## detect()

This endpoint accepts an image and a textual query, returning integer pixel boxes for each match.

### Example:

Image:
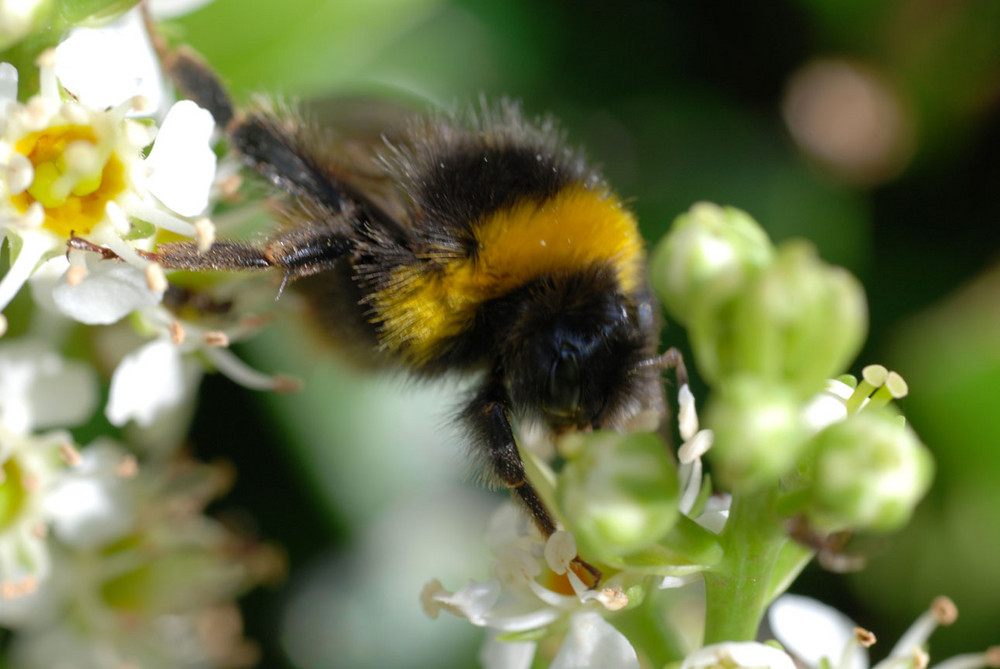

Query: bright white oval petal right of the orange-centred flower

[146,100,216,216]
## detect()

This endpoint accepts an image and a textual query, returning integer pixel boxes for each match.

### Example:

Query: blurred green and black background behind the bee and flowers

[169,0,1000,669]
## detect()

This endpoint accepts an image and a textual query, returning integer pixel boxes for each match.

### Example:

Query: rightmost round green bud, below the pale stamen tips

[805,409,934,532]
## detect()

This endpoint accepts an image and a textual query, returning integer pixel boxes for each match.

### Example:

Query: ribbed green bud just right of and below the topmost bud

[689,241,868,396]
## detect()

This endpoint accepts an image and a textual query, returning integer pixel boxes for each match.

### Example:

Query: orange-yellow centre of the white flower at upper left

[11,125,125,237]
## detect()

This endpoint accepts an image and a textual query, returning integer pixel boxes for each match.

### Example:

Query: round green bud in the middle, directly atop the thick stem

[705,376,808,491]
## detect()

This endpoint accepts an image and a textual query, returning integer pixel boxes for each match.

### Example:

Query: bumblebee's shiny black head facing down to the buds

[505,272,658,432]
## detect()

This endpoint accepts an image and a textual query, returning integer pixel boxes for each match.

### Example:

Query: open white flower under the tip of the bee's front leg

[421,503,639,669]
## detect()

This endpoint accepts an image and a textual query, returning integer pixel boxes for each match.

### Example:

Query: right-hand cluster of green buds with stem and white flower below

[425,204,960,669]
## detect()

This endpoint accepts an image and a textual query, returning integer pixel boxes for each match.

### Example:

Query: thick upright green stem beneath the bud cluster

[704,491,788,645]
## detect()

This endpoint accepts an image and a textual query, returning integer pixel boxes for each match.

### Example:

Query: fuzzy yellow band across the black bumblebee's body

[372,187,644,364]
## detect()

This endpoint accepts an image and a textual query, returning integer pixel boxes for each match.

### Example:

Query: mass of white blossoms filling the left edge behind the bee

[0,3,292,669]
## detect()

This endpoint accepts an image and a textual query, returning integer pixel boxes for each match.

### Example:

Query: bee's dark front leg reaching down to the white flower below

[465,379,601,588]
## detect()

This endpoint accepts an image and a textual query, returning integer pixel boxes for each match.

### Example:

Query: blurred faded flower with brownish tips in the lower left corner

[11,454,282,669]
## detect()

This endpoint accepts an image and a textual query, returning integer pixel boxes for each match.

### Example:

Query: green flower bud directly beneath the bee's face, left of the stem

[556,432,678,564]
